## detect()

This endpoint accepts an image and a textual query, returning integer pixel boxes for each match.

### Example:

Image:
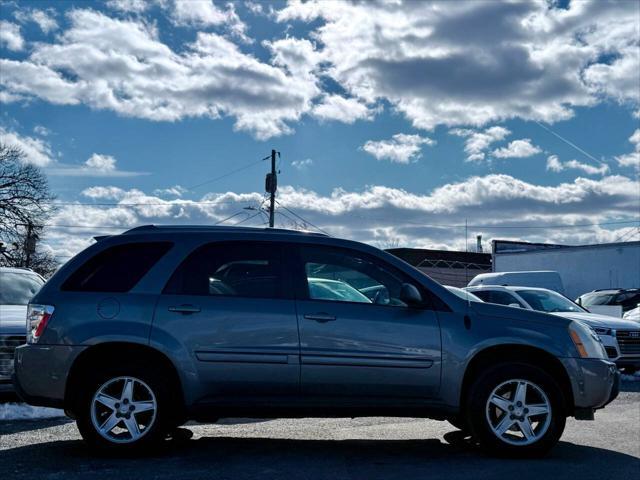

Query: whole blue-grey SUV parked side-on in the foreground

[15,226,618,456]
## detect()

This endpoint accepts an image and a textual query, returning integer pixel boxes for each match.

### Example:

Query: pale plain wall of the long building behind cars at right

[493,242,640,299]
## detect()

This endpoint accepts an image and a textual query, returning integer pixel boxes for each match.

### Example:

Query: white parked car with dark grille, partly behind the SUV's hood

[465,286,640,371]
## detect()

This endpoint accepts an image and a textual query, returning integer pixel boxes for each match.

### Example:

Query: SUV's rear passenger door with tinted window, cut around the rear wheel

[152,241,300,402]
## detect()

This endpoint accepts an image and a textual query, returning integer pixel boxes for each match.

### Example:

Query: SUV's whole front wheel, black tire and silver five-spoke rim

[467,363,566,457]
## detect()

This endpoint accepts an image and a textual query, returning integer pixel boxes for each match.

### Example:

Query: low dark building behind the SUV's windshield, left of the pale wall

[387,248,491,287]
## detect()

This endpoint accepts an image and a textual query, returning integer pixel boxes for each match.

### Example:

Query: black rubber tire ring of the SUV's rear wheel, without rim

[74,359,178,454]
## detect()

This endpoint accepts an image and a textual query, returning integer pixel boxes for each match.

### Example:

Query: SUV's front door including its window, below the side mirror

[296,245,441,401]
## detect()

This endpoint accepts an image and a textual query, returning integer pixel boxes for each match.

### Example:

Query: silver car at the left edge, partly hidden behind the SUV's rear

[0,267,44,392]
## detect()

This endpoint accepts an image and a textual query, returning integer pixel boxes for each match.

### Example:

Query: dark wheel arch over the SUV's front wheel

[459,344,574,415]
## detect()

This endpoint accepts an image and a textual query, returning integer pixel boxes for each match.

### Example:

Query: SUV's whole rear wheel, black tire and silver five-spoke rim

[74,364,174,451]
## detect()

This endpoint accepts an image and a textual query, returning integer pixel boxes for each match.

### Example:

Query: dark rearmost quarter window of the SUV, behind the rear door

[62,242,173,293]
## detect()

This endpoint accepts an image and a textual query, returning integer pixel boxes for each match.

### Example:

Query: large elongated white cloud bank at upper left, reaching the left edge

[0,9,320,139]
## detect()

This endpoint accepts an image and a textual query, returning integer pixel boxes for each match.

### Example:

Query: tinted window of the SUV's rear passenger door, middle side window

[164,242,285,298]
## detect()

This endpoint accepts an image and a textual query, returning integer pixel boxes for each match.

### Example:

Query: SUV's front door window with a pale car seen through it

[301,246,415,307]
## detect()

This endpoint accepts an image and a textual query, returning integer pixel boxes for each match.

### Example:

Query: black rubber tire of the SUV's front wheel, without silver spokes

[466,363,566,458]
